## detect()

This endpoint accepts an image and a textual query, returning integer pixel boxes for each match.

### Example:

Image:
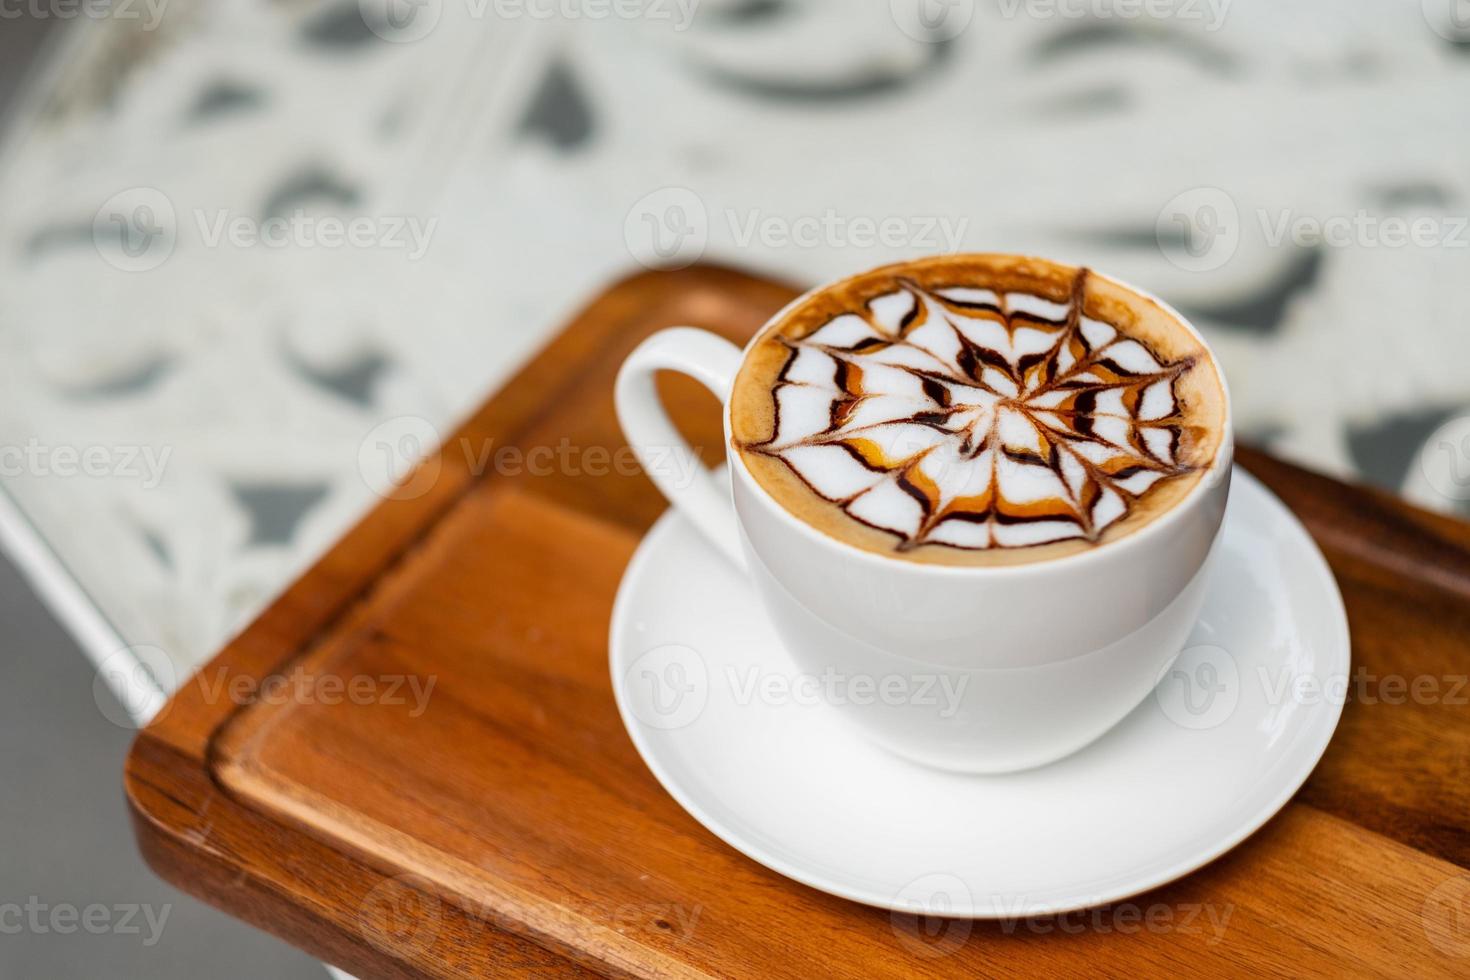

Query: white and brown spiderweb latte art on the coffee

[729,269,1223,564]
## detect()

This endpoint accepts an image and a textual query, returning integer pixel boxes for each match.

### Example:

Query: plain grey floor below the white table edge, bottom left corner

[0,549,326,980]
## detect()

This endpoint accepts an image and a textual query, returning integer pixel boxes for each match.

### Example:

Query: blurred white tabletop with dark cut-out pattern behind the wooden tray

[0,0,1470,685]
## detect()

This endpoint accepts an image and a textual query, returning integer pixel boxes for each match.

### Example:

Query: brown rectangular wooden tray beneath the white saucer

[126,267,1470,977]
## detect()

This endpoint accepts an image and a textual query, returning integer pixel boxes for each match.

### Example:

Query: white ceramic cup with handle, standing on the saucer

[616,273,1233,773]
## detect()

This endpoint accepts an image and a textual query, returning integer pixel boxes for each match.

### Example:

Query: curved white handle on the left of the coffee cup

[614,326,745,569]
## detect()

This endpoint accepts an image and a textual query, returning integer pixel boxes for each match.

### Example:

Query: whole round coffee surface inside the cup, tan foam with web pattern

[731,256,1226,564]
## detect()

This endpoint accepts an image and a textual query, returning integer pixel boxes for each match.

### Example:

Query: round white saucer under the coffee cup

[610,469,1348,918]
